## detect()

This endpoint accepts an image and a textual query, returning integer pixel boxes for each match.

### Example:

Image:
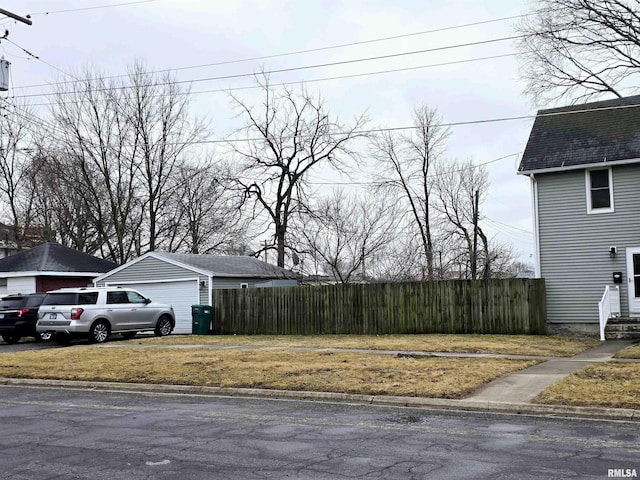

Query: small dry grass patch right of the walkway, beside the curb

[535,362,640,408]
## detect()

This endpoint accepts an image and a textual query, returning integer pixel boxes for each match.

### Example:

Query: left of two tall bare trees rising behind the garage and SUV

[51,71,144,263]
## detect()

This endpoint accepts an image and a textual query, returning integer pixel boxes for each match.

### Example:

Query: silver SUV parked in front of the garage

[36,287,175,344]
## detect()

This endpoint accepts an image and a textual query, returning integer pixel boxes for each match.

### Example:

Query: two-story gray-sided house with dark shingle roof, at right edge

[518,95,640,332]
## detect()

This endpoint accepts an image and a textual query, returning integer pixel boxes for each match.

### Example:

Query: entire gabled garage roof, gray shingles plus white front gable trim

[96,252,298,282]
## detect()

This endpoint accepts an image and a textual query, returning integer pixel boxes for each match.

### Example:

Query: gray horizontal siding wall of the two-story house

[536,165,640,323]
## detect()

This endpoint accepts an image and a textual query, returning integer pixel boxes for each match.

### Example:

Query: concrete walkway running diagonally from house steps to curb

[467,340,634,403]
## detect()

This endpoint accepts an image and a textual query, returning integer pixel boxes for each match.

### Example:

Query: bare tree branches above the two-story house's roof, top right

[517,0,640,105]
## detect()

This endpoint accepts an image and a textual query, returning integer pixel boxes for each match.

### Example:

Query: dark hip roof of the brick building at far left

[0,243,118,273]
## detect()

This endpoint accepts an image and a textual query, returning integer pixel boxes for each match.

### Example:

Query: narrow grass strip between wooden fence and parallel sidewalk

[137,334,600,357]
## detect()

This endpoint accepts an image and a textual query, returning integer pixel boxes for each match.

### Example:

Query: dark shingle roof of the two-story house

[518,95,640,173]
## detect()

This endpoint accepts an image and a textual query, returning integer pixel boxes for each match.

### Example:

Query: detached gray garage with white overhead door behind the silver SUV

[94,252,298,333]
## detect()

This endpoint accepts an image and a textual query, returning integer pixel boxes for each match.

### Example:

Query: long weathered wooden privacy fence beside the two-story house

[213,279,546,335]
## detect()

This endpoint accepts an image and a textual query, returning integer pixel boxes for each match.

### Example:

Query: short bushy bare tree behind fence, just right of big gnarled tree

[297,189,398,283]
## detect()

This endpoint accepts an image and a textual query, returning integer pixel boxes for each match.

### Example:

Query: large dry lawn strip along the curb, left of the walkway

[0,346,539,398]
